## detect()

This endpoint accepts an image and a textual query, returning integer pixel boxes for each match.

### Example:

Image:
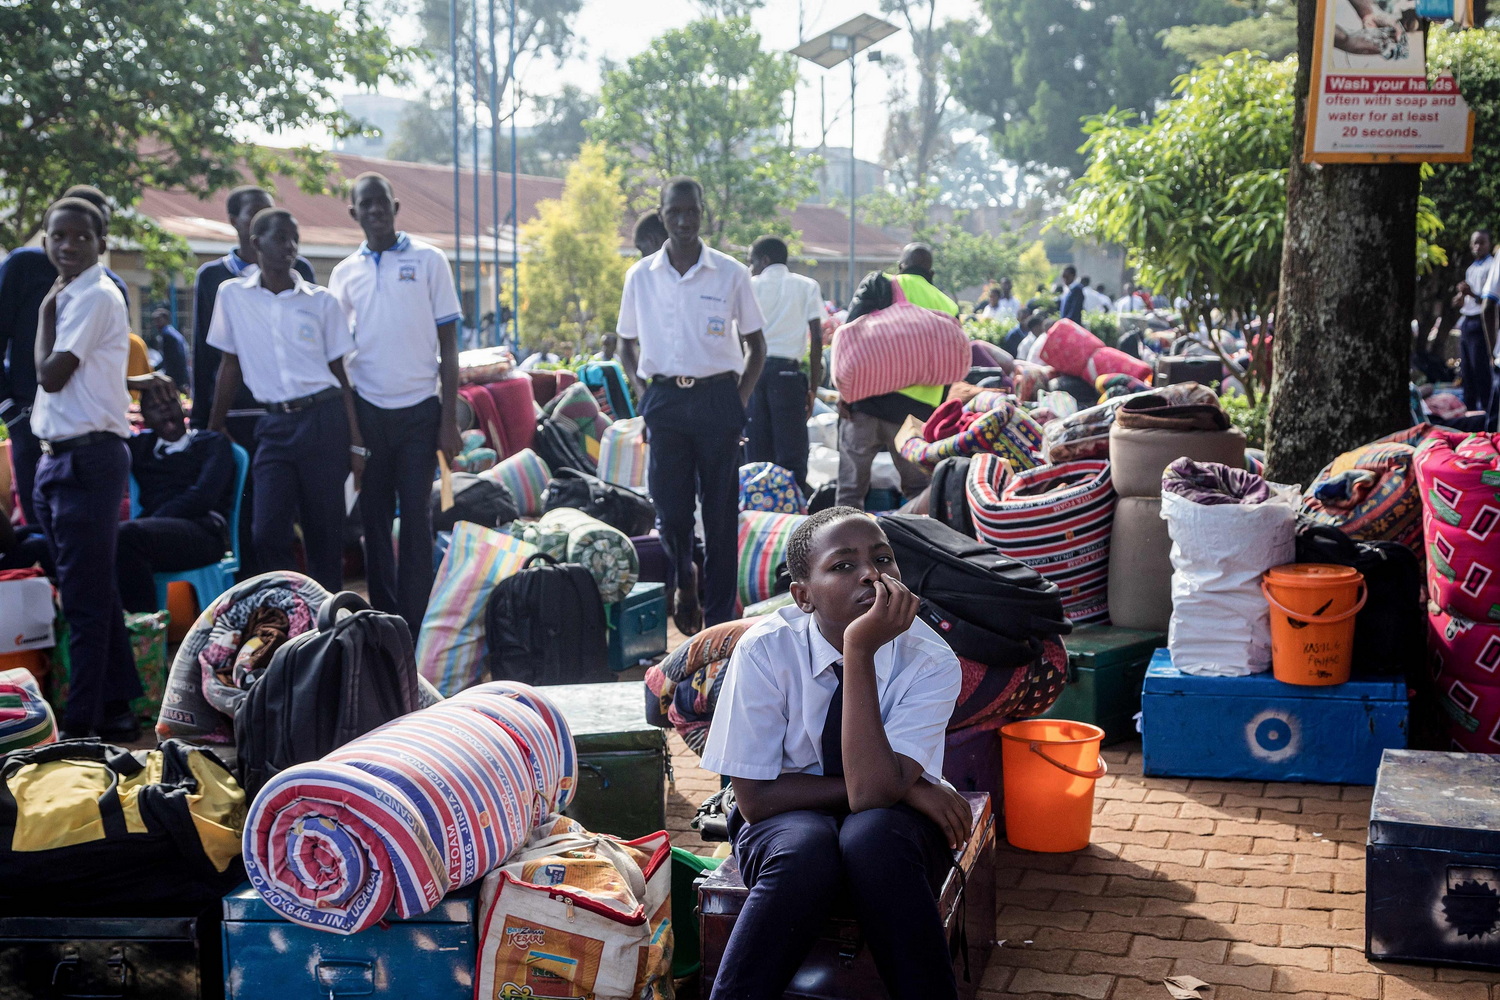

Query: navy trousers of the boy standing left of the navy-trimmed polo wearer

[251,399,350,592]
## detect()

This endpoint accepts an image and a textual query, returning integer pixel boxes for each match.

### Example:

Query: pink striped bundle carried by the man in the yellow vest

[833,282,969,403]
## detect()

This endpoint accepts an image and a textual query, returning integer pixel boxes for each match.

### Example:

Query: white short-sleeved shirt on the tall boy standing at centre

[615,243,768,379]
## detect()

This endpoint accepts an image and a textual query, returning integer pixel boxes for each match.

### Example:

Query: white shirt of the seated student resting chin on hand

[702,607,963,781]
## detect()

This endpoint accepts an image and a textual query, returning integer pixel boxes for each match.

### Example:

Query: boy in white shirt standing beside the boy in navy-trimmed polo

[209,208,366,591]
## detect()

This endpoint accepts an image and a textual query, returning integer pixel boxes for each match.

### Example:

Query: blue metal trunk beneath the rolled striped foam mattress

[222,882,479,1000]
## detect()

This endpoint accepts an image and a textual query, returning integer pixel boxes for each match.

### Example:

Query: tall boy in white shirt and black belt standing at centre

[617,177,765,636]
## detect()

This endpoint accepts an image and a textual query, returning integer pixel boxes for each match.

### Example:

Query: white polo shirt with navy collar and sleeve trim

[329,232,464,409]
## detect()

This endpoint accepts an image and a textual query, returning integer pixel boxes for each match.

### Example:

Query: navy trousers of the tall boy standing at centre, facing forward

[641,378,746,625]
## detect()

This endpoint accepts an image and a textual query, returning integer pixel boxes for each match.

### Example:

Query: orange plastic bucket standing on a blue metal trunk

[1260,562,1368,687]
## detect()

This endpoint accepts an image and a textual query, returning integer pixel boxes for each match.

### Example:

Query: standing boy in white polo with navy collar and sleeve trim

[329,174,464,636]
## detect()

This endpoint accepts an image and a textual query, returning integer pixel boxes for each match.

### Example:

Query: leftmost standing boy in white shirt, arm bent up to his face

[32,198,165,741]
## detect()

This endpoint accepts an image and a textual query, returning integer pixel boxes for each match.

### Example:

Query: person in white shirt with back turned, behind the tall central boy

[746,235,824,495]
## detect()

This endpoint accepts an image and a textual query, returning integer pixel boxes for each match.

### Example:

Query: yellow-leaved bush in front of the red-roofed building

[521,144,629,354]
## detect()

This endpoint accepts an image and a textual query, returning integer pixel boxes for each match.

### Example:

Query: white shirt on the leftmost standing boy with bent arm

[32,264,131,441]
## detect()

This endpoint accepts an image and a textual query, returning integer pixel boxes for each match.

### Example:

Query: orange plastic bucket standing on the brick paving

[1001,718,1109,853]
